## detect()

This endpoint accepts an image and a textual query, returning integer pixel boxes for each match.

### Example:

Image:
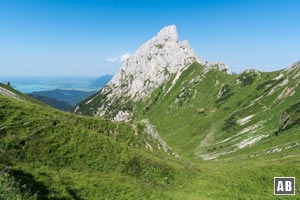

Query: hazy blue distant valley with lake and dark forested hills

[0,75,112,111]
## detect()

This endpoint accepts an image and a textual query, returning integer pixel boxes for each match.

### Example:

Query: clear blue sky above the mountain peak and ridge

[0,0,300,76]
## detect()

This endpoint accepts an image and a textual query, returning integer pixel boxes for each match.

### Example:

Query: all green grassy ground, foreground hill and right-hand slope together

[0,61,300,200]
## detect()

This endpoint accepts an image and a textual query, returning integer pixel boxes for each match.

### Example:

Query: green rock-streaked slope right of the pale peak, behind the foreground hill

[135,64,300,161]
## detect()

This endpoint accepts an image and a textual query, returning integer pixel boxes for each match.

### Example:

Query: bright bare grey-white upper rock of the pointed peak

[108,25,203,101]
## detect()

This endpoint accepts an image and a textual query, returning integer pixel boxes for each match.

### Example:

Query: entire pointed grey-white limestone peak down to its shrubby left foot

[74,25,231,121]
